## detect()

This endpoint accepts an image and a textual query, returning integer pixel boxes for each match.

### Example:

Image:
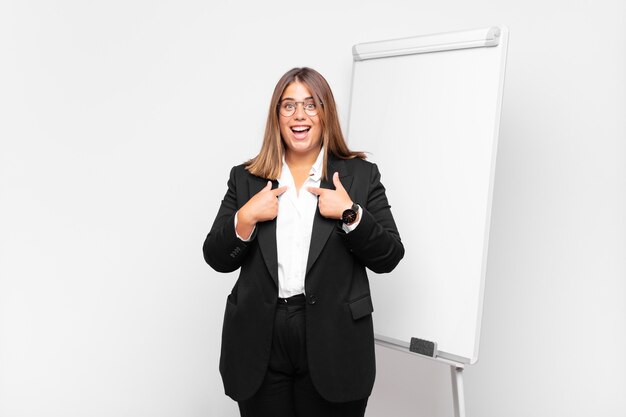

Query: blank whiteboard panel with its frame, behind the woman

[347,27,508,363]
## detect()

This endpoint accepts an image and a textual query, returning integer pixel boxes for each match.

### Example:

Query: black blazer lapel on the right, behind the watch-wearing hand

[306,155,352,274]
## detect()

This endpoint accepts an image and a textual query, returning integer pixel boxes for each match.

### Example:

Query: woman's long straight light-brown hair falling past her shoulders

[246,67,366,180]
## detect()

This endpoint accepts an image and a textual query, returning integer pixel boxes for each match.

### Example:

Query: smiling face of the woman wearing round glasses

[278,81,322,158]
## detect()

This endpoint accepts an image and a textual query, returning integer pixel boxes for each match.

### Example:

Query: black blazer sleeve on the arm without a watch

[202,167,256,272]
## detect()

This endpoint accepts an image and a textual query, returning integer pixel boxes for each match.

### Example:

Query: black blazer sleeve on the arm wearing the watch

[344,164,404,273]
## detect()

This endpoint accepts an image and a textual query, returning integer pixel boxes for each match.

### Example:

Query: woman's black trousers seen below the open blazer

[239,295,367,417]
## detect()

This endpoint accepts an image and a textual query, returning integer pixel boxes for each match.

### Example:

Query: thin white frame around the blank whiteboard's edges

[346,26,509,366]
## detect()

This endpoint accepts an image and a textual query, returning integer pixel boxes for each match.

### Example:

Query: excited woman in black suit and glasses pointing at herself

[203,68,404,417]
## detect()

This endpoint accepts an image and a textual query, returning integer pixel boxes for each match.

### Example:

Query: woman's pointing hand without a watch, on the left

[237,181,287,238]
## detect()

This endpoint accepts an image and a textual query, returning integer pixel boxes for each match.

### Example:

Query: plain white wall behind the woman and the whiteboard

[0,0,626,417]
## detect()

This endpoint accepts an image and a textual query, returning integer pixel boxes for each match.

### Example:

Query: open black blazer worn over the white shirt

[203,155,404,402]
